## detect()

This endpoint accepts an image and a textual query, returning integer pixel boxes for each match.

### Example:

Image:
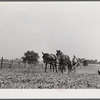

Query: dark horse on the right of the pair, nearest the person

[56,50,72,73]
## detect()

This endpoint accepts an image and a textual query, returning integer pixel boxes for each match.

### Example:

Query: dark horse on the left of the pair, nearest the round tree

[42,52,57,72]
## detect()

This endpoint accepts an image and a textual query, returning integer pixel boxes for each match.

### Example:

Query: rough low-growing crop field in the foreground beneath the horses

[0,63,100,89]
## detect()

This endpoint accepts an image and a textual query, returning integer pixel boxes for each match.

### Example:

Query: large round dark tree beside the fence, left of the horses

[22,51,39,64]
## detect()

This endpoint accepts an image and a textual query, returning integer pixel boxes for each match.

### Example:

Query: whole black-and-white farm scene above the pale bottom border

[0,1,100,89]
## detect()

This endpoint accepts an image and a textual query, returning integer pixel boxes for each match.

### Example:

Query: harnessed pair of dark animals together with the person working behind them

[42,50,79,73]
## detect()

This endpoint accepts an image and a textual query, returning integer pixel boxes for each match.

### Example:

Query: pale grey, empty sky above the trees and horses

[0,1,100,61]
